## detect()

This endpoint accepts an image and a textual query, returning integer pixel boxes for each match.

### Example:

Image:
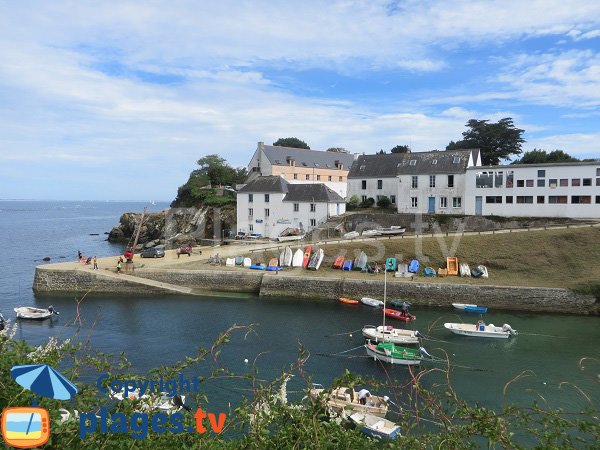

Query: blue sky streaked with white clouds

[0,0,600,201]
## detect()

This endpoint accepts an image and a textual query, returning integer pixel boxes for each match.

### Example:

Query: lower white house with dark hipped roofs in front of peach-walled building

[237,176,346,238]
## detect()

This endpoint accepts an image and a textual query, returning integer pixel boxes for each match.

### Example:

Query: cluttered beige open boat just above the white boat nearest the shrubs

[308,384,389,417]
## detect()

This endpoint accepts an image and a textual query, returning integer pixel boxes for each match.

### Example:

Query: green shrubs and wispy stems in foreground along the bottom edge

[0,325,600,449]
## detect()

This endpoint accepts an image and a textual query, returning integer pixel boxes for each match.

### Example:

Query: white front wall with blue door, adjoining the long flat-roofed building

[396,173,466,214]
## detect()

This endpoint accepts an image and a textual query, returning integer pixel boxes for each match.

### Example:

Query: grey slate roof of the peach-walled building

[263,145,354,170]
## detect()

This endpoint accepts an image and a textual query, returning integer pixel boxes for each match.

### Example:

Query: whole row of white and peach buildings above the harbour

[237,142,600,238]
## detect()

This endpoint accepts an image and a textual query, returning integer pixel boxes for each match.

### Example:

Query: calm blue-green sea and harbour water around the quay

[0,201,600,418]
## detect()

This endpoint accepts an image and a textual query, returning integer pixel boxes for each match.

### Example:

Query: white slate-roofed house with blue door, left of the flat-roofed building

[348,149,481,214]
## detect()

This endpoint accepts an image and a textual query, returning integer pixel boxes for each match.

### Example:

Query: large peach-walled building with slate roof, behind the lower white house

[248,142,354,198]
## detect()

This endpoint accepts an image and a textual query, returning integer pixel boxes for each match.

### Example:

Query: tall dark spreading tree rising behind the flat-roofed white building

[446,117,525,165]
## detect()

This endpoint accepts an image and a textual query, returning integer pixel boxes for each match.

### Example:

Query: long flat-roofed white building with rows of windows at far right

[465,161,600,218]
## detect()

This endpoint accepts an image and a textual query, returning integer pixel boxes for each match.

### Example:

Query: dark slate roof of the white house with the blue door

[348,149,479,178]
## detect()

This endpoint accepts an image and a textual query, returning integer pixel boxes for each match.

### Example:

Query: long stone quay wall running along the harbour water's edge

[33,265,600,315]
